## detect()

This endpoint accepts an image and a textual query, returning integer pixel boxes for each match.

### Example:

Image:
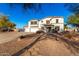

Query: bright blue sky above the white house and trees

[0,3,71,28]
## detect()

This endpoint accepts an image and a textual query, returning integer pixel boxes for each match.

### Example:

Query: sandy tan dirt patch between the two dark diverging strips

[21,38,78,56]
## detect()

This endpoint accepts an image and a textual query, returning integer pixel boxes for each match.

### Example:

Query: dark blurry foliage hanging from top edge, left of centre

[8,3,41,12]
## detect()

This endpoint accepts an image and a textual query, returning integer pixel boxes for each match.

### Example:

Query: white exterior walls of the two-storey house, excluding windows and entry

[25,17,64,32]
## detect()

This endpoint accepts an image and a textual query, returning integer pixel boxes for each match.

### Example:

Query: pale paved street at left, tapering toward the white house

[0,32,30,44]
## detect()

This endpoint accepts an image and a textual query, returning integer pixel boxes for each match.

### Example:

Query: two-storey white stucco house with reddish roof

[24,16,64,32]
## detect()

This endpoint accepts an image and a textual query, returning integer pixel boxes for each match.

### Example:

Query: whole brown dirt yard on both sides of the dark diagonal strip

[0,34,79,56]
